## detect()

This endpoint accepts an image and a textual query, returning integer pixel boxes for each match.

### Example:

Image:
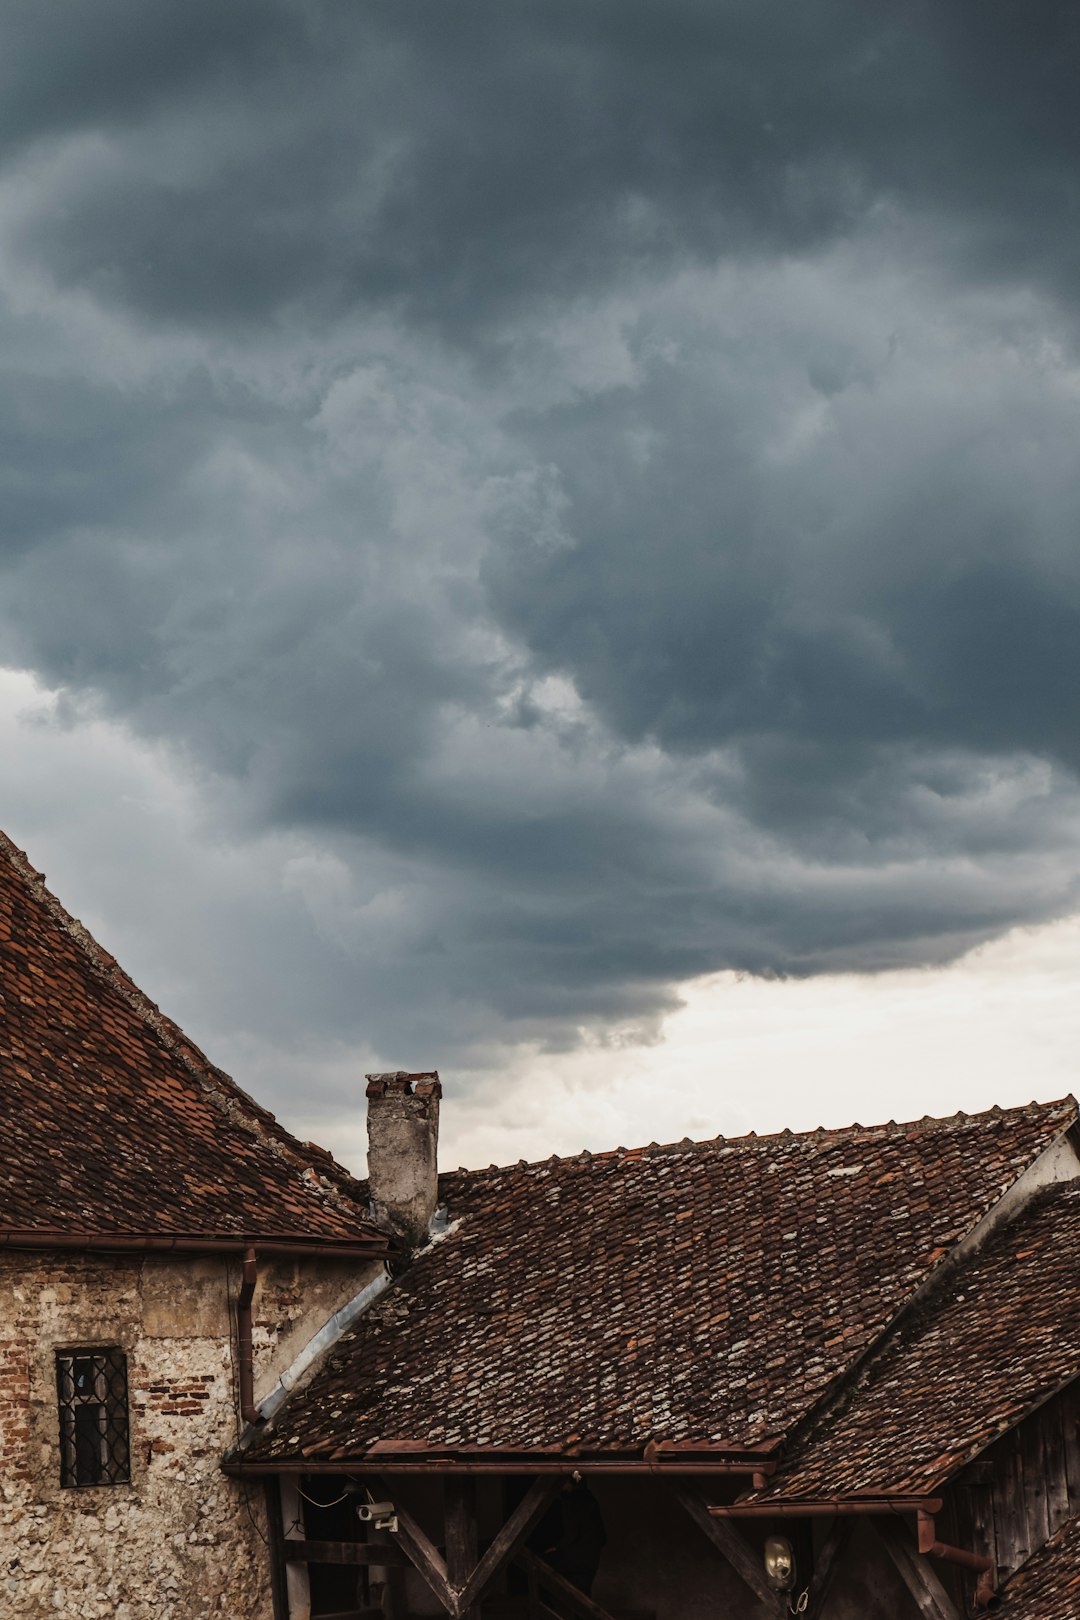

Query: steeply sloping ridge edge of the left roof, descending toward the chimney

[0,829,372,1218]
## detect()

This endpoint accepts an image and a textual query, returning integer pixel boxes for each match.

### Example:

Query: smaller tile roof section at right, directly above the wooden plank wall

[767,1183,1080,1497]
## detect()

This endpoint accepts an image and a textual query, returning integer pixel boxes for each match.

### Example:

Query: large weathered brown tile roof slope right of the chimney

[248,1100,1075,1458]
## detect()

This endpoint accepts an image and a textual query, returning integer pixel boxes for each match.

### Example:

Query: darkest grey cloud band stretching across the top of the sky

[14,0,1080,332]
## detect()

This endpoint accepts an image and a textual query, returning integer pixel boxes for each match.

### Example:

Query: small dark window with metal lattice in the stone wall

[57,1349,131,1486]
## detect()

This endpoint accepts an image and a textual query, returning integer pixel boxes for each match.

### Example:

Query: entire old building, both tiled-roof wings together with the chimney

[0,841,1080,1620]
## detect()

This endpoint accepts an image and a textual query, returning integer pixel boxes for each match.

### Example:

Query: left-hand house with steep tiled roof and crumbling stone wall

[0,838,390,1620]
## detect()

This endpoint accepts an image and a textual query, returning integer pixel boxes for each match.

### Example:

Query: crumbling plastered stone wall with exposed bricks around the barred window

[0,1252,379,1620]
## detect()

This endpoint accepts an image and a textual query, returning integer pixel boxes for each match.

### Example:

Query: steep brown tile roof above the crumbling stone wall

[0,834,386,1243]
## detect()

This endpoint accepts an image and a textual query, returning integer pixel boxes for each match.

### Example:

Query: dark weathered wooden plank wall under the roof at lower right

[949,1380,1080,1600]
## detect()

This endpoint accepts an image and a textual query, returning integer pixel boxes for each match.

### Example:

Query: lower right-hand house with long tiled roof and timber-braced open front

[238,1077,1080,1620]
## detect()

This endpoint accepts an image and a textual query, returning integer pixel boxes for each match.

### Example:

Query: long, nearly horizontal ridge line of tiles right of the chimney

[440,1094,1080,1179]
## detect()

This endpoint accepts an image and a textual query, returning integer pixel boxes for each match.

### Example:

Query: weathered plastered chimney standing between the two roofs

[364,1069,442,1244]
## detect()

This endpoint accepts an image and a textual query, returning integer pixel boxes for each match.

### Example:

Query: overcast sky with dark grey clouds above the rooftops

[0,0,1080,1162]
